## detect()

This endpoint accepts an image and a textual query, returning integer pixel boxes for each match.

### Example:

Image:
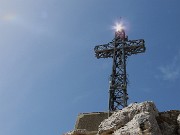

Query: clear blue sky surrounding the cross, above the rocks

[0,0,180,135]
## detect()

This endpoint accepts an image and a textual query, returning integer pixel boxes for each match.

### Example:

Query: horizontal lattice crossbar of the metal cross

[94,39,146,59]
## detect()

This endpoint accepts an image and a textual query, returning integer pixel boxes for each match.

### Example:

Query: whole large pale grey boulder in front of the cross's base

[98,102,161,135]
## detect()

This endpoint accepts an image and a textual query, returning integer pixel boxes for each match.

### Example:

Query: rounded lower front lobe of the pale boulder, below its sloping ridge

[114,112,162,135]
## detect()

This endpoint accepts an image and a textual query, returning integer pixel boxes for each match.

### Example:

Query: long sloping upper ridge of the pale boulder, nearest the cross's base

[98,102,158,134]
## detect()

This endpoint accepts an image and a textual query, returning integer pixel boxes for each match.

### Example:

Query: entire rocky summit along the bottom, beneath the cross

[65,101,180,135]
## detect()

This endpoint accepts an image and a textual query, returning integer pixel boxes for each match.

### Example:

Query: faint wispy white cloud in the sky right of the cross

[158,51,180,80]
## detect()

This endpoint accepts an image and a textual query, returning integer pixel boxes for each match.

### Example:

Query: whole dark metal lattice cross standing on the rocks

[94,30,146,111]
